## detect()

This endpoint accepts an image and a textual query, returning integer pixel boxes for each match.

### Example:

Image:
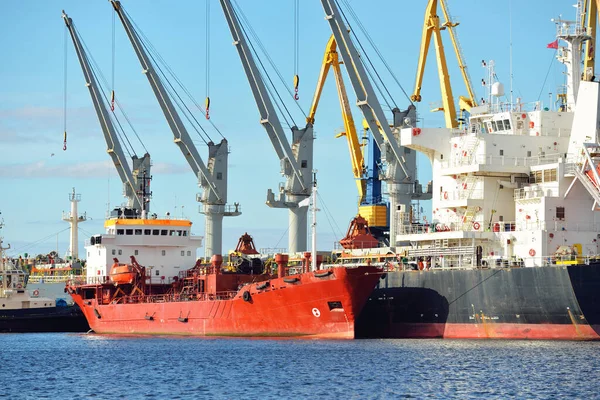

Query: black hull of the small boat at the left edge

[0,305,90,333]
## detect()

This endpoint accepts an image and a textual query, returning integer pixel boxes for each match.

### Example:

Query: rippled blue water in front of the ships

[0,334,600,399]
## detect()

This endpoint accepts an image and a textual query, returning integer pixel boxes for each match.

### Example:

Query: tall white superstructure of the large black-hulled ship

[396,11,600,267]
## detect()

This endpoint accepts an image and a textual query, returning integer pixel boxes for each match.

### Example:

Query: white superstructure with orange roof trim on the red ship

[85,213,203,283]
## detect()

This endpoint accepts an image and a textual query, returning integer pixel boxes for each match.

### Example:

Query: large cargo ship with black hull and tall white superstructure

[328,1,600,340]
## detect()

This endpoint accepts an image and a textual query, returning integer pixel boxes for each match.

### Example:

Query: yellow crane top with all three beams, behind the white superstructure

[410,0,477,128]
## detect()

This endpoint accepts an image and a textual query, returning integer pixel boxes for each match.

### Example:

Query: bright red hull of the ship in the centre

[71,267,381,339]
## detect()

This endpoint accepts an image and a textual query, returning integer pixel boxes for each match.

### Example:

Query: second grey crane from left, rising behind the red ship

[111,0,241,257]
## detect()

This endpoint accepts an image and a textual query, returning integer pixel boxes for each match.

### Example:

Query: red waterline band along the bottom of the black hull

[384,322,600,340]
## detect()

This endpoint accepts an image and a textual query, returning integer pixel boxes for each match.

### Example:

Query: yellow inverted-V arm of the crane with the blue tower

[306,35,366,204]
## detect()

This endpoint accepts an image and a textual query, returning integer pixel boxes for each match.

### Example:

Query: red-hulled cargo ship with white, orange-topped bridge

[66,218,382,339]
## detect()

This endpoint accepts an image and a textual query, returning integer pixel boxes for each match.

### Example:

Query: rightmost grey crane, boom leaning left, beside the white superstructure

[321,0,416,246]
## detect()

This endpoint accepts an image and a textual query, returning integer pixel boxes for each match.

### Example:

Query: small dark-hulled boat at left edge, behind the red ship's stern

[0,217,89,333]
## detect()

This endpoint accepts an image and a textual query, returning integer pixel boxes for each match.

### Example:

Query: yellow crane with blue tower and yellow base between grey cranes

[306,35,388,238]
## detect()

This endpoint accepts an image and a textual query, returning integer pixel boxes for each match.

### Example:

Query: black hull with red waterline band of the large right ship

[356,263,600,340]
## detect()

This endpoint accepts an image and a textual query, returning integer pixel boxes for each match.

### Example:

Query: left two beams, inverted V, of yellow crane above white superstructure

[411,0,458,128]
